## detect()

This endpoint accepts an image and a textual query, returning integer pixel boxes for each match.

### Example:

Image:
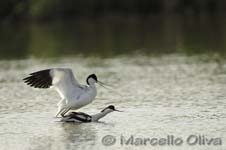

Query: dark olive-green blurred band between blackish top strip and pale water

[0,15,226,59]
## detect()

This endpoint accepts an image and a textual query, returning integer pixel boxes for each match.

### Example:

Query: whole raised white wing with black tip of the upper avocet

[23,68,84,99]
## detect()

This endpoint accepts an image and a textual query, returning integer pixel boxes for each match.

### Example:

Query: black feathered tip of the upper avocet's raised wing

[23,69,53,88]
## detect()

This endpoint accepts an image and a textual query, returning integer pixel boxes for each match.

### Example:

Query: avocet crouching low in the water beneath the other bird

[61,105,122,123]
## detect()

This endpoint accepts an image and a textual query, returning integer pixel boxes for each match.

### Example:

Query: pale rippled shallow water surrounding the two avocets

[0,55,226,150]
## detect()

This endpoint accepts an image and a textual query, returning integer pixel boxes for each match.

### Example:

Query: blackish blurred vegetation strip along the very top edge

[0,0,226,21]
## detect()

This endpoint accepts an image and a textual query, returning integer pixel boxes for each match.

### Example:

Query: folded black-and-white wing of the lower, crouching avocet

[61,112,92,122]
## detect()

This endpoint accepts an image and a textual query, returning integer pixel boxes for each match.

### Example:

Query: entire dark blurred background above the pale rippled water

[0,0,226,59]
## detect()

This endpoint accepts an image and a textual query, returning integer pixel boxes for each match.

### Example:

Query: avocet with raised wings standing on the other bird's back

[23,68,107,117]
